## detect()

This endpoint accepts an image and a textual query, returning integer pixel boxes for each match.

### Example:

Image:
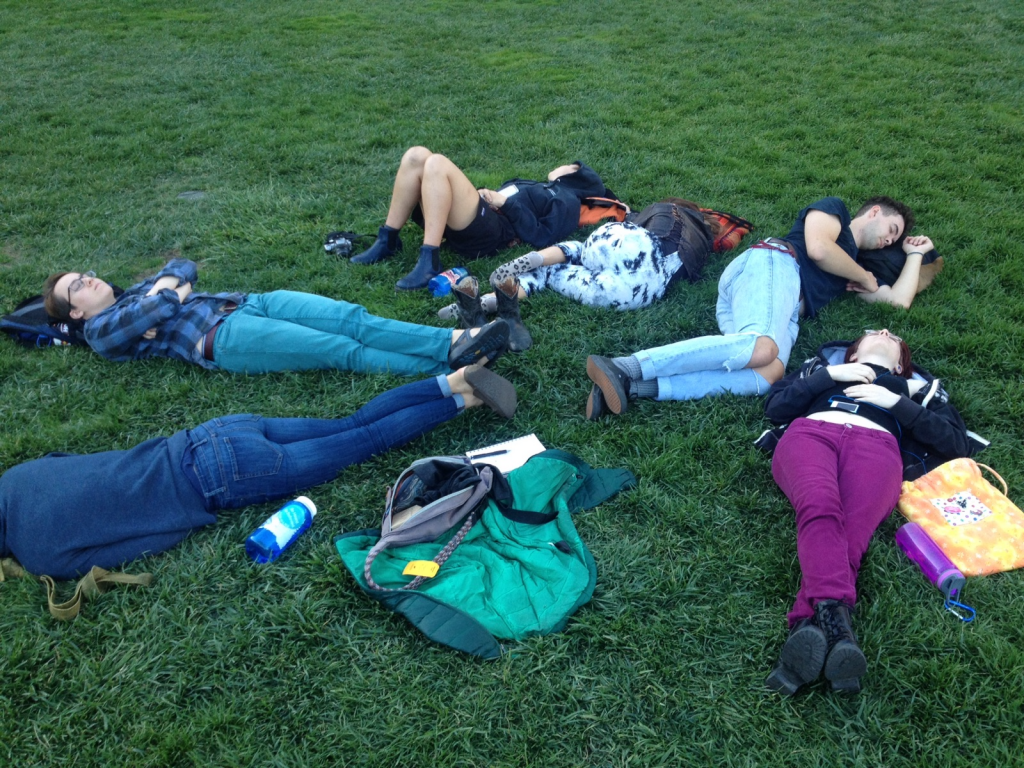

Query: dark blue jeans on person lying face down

[182,376,463,512]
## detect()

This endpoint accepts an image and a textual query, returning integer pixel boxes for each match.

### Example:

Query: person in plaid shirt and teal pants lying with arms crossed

[43,259,508,376]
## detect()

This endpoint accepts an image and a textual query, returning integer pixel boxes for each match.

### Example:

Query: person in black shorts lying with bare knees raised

[351,146,611,290]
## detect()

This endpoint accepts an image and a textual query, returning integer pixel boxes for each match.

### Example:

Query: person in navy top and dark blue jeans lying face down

[0,365,516,579]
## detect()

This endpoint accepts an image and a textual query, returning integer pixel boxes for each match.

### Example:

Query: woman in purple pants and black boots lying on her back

[759,330,975,695]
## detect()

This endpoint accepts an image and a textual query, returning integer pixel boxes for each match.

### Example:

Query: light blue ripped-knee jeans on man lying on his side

[636,248,800,400]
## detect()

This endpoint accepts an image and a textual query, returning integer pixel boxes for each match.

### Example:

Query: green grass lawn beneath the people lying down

[0,0,1024,768]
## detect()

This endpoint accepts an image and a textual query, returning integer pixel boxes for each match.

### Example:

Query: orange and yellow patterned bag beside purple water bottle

[899,459,1024,575]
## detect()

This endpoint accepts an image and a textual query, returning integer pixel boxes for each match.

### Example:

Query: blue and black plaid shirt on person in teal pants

[85,259,246,369]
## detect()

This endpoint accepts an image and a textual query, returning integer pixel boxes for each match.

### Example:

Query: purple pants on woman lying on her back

[772,419,903,627]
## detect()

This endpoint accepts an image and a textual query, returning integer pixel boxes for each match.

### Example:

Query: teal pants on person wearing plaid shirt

[213,291,452,376]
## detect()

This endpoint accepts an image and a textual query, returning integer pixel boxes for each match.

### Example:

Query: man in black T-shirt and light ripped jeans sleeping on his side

[587,197,934,419]
